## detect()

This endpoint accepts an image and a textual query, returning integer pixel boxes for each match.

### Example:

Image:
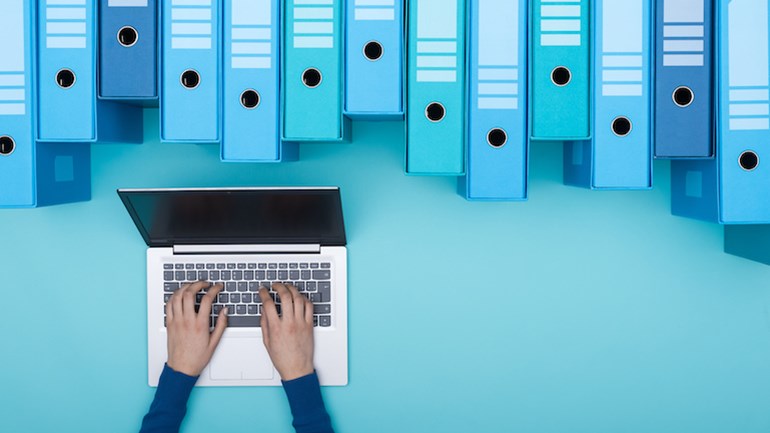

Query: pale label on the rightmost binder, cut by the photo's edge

[727,0,770,131]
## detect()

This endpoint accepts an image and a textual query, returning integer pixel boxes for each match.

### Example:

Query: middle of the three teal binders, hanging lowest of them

[406,0,466,176]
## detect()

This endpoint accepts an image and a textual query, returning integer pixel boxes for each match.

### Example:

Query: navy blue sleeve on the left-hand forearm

[140,364,198,433]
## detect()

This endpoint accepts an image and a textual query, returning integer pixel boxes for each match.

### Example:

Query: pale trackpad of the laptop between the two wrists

[209,338,273,380]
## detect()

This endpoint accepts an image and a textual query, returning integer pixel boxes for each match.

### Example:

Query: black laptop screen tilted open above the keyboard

[118,188,345,247]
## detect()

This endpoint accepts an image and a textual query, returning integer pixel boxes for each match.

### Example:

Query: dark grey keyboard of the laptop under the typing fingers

[163,262,332,327]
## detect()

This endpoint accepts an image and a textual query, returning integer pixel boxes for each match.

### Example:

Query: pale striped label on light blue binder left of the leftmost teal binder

[230,0,272,69]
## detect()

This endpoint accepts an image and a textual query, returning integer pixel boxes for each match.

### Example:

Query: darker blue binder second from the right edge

[655,0,716,158]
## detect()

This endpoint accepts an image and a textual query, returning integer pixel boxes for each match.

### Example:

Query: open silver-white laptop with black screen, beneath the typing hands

[118,188,348,386]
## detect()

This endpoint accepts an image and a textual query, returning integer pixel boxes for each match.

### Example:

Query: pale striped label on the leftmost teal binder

[292,0,334,48]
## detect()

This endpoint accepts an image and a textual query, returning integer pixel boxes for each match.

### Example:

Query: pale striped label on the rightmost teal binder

[540,0,585,47]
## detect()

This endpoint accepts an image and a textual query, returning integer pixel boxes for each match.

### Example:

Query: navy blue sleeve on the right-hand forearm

[282,372,334,433]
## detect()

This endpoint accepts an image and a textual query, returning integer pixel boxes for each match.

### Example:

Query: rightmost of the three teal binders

[530,0,591,140]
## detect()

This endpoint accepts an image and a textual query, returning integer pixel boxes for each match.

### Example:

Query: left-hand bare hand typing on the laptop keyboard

[166,281,227,376]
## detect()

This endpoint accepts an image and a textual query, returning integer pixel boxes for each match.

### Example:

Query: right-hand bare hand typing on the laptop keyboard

[259,283,314,381]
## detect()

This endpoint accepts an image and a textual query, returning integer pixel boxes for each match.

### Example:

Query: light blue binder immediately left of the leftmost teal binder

[221,0,298,162]
